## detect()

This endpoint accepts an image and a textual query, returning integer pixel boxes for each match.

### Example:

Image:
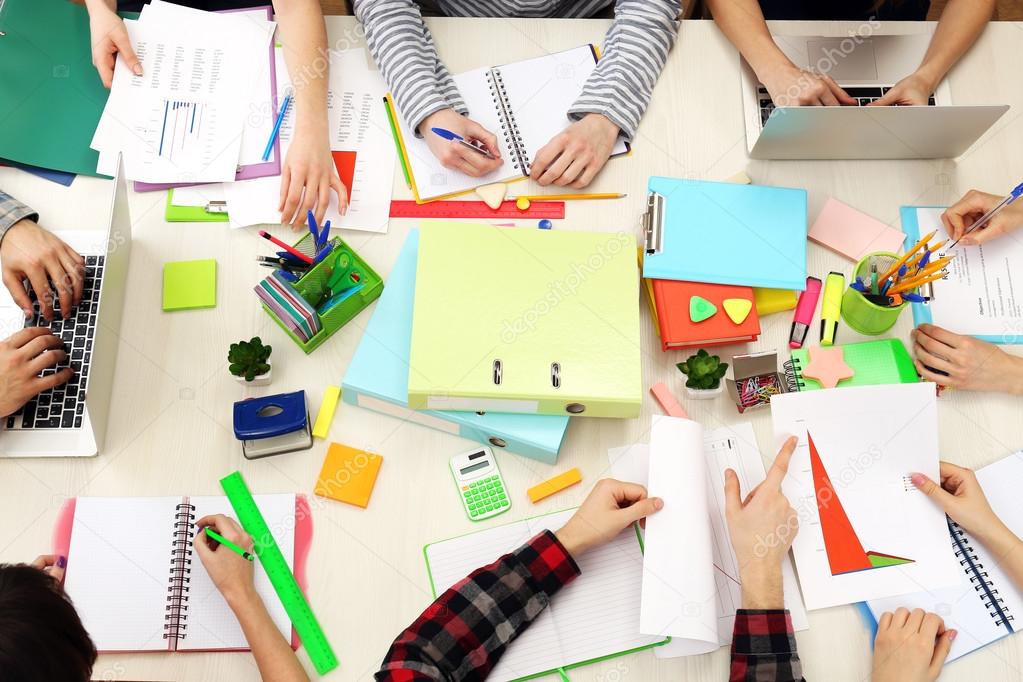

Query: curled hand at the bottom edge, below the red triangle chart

[871,608,957,682]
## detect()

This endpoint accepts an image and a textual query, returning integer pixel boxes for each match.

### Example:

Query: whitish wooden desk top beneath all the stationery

[0,17,1023,681]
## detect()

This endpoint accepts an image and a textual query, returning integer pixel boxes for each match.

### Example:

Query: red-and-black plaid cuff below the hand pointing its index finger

[728,608,803,682]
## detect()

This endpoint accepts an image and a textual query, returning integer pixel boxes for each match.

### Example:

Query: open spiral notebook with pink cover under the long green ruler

[57,495,296,652]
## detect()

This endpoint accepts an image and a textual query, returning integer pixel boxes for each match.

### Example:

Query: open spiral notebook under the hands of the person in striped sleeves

[395,45,629,203]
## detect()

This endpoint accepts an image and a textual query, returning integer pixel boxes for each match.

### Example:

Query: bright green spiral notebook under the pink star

[785,338,920,391]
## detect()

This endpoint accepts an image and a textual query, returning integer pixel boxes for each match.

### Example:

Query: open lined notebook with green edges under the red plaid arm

[424,509,665,682]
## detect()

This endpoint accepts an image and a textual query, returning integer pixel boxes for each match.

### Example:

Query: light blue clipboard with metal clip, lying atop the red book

[642,177,806,290]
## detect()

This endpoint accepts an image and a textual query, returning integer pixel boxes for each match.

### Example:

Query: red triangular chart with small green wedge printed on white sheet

[806,434,913,576]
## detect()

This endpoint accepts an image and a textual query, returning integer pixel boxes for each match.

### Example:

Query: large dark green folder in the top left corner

[0,0,134,176]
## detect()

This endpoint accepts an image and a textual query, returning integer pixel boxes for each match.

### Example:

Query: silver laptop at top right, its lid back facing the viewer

[742,34,1009,158]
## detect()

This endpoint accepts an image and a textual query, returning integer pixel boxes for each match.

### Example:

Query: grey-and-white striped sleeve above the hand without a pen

[569,0,681,139]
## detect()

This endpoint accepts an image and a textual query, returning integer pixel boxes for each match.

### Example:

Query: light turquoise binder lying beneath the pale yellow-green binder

[342,229,569,464]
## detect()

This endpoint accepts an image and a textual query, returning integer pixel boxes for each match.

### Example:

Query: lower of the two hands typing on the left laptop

[0,327,74,417]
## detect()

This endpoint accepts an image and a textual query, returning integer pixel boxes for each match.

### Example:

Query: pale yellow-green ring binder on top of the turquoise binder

[408,221,642,417]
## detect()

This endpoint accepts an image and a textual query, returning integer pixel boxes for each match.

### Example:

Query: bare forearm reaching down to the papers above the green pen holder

[273,0,330,139]
